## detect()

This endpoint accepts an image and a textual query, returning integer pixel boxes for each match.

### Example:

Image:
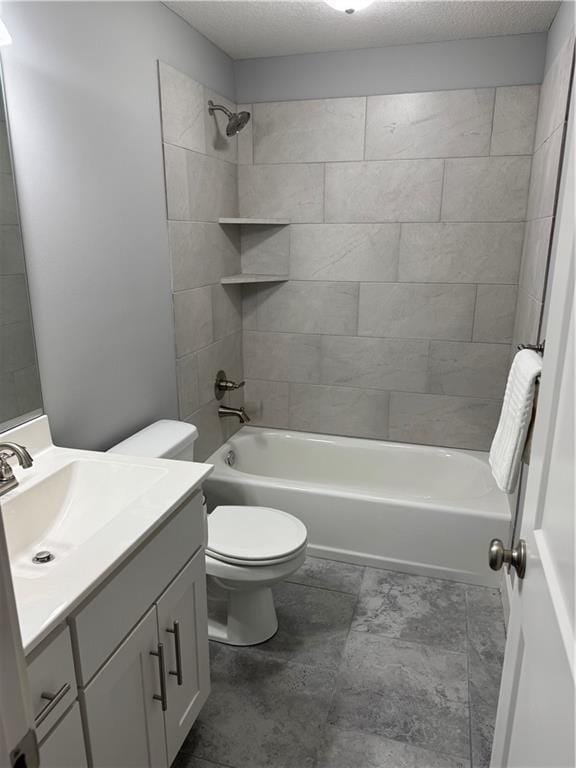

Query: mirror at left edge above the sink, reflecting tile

[0,69,42,431]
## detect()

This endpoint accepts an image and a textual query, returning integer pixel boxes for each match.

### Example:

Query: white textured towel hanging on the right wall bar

[489,349,542,493]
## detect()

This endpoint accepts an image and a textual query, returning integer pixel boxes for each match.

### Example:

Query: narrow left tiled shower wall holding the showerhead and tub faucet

[159,63,243,459]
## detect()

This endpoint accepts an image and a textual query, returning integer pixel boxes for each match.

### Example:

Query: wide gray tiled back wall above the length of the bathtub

[238,86,539,449]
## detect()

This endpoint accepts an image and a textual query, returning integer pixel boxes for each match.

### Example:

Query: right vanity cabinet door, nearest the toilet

[157,550,210,764]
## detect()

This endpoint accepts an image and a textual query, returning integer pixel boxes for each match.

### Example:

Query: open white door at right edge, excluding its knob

[491,87,576,768]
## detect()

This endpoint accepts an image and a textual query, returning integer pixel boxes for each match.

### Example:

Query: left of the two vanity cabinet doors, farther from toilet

[81,608,167,768]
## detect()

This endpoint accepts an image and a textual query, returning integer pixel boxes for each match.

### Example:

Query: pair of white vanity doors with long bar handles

[81,551,210,768]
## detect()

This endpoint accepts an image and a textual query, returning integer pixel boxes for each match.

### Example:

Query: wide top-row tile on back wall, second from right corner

[366,88,494,160]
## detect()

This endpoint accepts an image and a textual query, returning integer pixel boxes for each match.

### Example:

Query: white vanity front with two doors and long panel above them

[71,494,210,768]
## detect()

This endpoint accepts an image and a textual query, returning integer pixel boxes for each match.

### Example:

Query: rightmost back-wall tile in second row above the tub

[428,341,510,398]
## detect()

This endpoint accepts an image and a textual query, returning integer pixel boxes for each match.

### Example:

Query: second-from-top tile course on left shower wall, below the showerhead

[164,144,238,221]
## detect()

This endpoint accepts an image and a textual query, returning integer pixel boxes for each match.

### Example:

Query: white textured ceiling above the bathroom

[166,0,559,59]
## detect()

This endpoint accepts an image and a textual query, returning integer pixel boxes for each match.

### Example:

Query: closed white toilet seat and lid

[206,506,308,567]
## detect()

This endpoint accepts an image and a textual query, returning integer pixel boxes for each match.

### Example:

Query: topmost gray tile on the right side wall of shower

[534,34,574,149]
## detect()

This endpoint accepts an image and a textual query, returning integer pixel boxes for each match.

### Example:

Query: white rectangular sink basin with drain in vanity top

[2,459,168,577]
